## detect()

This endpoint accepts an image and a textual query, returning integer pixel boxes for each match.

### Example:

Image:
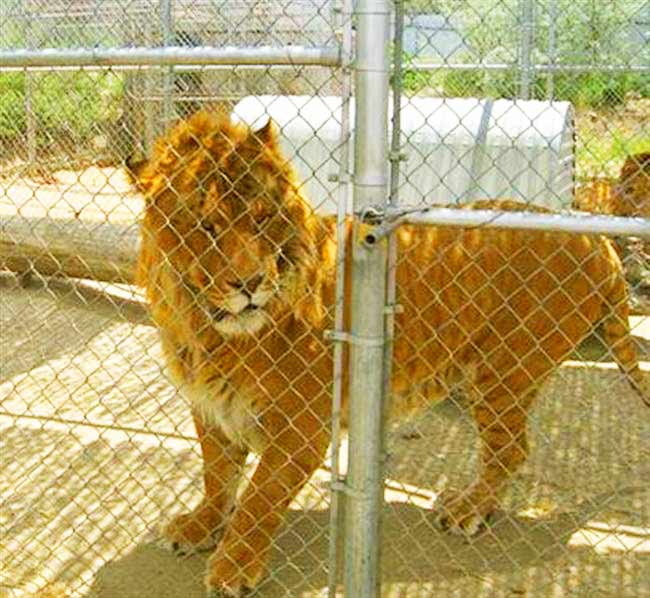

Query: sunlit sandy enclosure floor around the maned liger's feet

[0,169,650,598]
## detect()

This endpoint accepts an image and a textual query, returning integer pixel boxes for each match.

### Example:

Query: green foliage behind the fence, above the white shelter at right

[405,0,650,107]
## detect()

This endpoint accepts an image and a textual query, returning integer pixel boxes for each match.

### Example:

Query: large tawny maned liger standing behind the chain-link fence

[124,112,650,597]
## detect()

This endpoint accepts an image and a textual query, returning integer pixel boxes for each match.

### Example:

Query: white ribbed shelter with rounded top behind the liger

[234,96,574,213]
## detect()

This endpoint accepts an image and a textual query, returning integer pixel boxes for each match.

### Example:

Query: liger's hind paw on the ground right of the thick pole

[436,488,498,537]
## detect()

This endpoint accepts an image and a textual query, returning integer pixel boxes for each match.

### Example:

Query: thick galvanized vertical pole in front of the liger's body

[345,0,390,598]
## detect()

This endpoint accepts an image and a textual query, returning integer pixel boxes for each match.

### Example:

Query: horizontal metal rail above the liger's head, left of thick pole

[0,46,341,68]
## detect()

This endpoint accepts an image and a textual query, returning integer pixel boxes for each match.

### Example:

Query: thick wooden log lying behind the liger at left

[0,216,139,284]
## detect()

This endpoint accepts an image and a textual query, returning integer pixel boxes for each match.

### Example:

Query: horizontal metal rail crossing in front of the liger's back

[364,208,650,245]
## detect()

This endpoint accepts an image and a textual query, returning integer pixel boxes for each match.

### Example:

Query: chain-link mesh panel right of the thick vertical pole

[382,0,650,596]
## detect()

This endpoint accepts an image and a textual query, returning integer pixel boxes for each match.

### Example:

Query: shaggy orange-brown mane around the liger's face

[129,111,335,332]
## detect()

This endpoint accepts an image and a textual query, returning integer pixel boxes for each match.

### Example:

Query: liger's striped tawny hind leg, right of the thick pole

[438,384,536,536]
